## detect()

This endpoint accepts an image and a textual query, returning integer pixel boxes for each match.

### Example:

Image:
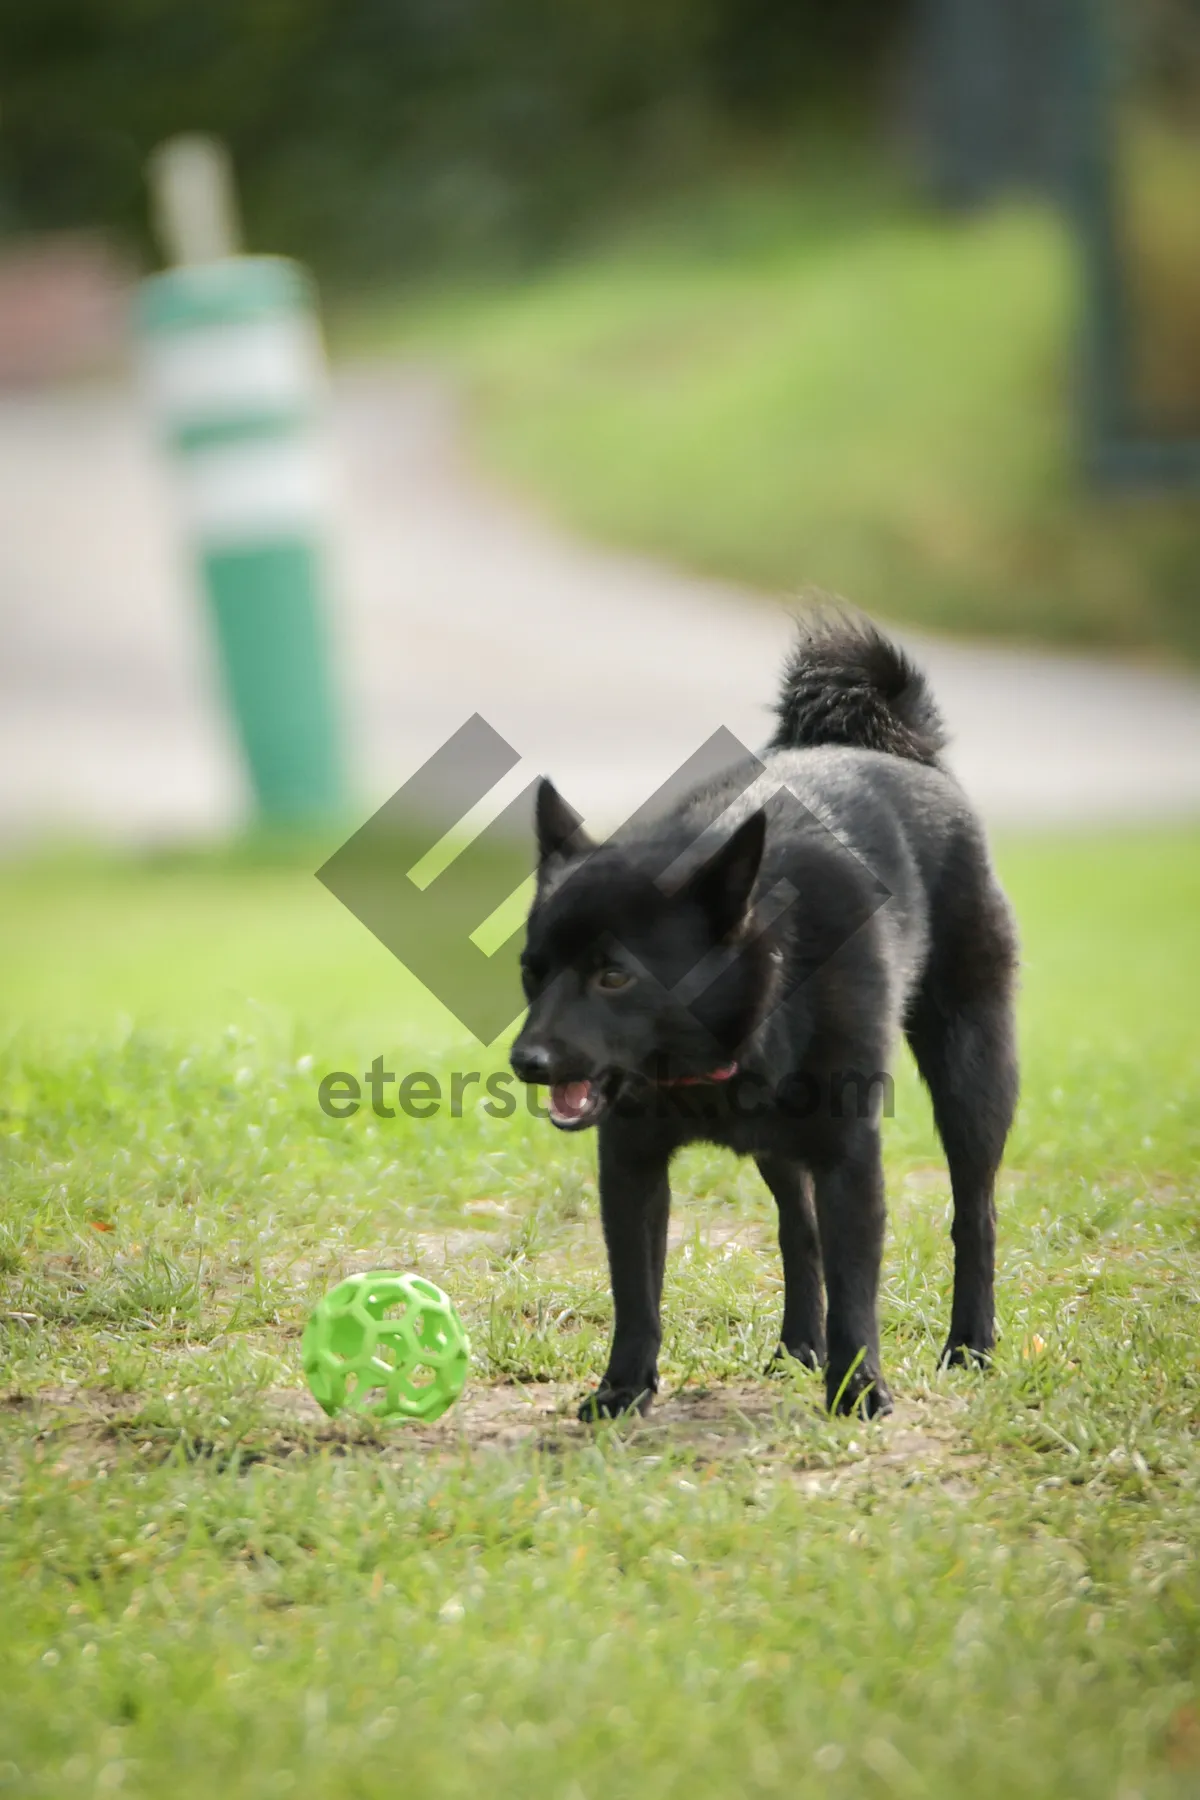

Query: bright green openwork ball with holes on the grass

[300,1271,471,1422]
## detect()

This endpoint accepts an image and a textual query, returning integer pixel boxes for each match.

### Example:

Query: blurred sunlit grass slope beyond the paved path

[352,173,1200,655]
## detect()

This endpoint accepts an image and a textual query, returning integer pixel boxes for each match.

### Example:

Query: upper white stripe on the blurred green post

[144,313,324,427]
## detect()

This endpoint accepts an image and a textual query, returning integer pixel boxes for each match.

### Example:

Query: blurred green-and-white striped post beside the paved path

[139,137,342,824]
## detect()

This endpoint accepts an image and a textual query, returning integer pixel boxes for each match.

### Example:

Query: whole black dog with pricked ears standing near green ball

[513,614,1016,1417]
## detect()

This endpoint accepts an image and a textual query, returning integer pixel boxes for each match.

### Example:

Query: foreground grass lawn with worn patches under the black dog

[0,831,1200,1800]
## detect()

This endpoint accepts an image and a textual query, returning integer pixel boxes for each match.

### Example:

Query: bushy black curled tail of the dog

[770,612,946,763]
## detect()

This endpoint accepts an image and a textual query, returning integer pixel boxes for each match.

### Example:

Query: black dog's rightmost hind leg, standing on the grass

[907,981,1016,1364]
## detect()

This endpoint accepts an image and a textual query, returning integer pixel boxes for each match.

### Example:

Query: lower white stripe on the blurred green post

[180,436,327,547]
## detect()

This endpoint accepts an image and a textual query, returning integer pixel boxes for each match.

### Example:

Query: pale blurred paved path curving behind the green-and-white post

[0,369,1200,841]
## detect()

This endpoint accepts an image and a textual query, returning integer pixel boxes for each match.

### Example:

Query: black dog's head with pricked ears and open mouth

[511,781,774,1130]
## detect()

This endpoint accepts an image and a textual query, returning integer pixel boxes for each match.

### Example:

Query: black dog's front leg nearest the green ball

[579,1118,671,1418]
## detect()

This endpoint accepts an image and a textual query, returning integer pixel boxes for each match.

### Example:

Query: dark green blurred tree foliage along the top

[0,0,909,275]
